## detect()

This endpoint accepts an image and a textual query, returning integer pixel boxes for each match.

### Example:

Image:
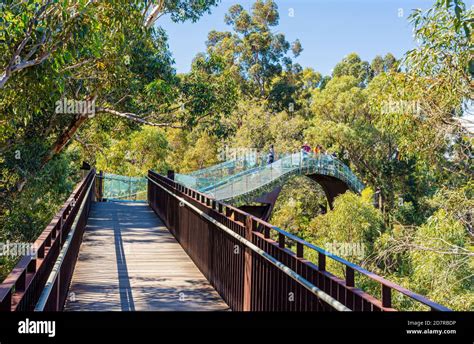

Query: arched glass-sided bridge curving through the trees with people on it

[175,152,364,203]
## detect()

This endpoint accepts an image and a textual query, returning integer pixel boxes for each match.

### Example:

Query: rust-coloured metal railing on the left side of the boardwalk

[0,170,95,311]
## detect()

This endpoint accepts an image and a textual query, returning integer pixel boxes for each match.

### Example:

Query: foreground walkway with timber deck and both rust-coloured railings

[0,165,449,312]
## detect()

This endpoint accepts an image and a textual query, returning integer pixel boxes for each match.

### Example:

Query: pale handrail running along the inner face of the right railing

[147,177,352,312]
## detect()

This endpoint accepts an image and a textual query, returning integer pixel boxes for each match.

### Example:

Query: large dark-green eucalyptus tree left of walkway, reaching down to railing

[0,0,222,253]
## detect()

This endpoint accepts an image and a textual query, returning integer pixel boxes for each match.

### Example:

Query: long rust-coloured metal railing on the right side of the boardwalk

[148,171,449,311]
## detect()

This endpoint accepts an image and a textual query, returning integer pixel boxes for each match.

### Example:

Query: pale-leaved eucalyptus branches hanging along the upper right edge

[404,0,474,180]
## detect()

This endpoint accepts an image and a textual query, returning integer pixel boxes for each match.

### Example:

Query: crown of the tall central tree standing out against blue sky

[207,0,302,97]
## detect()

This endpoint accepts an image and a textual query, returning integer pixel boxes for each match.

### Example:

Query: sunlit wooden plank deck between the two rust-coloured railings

[65,202,229,311]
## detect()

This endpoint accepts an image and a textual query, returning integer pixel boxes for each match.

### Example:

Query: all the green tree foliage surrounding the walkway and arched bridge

[0,0,474,310]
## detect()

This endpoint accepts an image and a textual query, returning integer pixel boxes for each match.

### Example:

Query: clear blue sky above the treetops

[156,0,440,74]
